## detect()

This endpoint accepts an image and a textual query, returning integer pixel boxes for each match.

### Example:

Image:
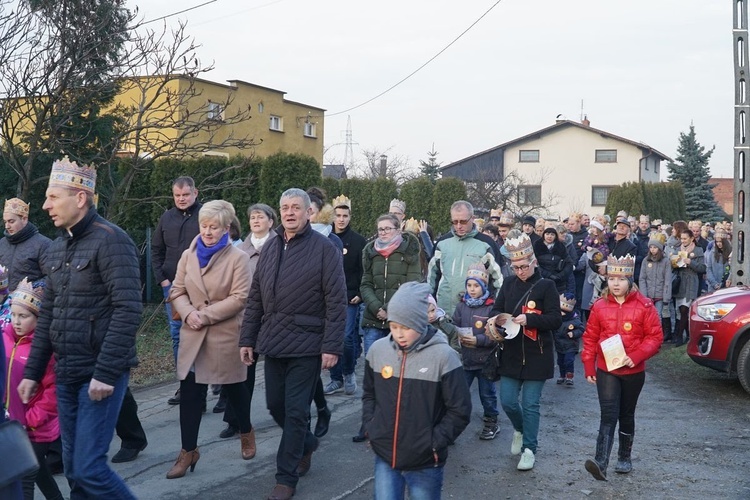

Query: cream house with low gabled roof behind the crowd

[442,119,671,219]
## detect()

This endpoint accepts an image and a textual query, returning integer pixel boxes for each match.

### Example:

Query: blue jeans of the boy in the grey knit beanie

[375,455,443,500]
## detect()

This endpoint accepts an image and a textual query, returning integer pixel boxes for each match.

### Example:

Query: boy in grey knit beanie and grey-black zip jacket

[362,282,471,500]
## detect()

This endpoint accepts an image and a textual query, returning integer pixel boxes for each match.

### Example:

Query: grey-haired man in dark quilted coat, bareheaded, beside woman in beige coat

[239,188,347,499]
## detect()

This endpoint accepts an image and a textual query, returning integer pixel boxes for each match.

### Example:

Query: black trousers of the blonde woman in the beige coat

[180,372,250,451]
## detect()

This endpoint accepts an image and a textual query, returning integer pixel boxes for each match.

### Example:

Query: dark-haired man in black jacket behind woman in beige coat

[151,177,202,405]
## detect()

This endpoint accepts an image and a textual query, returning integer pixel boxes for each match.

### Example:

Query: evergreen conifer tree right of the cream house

[667,124,724,221]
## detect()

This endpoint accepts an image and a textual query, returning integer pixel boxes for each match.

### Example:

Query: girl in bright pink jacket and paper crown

[2,279,63,500]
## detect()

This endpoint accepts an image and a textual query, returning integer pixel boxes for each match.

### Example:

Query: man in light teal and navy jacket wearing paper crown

[428,200,503,314]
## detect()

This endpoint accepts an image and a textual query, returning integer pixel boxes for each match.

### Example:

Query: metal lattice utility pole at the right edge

[730,0,750,285]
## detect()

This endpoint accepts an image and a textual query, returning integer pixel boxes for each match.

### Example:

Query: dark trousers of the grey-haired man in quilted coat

[265,356,321,488]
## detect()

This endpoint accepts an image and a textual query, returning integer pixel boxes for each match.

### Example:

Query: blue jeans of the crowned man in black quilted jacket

[57,373,135,500]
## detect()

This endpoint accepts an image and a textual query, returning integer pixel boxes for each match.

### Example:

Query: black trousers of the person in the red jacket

[596,370,646,435]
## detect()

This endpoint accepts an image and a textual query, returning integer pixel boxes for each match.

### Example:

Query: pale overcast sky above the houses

[147,0,735,177]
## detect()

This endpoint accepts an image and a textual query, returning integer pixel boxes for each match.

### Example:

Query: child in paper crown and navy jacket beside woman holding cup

[453,264,498,440]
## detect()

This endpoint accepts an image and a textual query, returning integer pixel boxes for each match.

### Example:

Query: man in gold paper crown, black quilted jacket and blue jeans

[18,158,143,499]
